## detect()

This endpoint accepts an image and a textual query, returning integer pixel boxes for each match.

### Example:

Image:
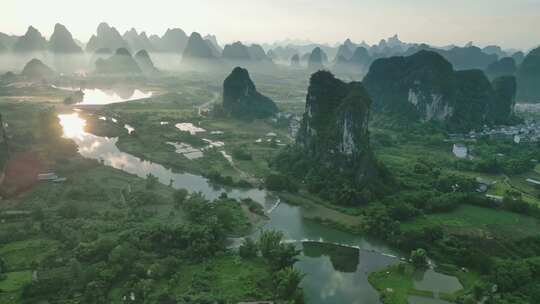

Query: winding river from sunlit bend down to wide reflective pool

[59,112,460,304]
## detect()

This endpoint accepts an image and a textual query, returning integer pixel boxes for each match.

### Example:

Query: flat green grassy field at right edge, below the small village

[401,205,540,239]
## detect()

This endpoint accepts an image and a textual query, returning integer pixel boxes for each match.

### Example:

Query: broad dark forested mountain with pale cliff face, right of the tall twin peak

[363,50,515,130]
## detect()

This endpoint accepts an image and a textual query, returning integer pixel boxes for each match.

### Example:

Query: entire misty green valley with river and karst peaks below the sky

[0,11,540,304]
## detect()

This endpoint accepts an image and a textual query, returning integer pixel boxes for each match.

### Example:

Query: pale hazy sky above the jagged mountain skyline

[4,0,540,48]
